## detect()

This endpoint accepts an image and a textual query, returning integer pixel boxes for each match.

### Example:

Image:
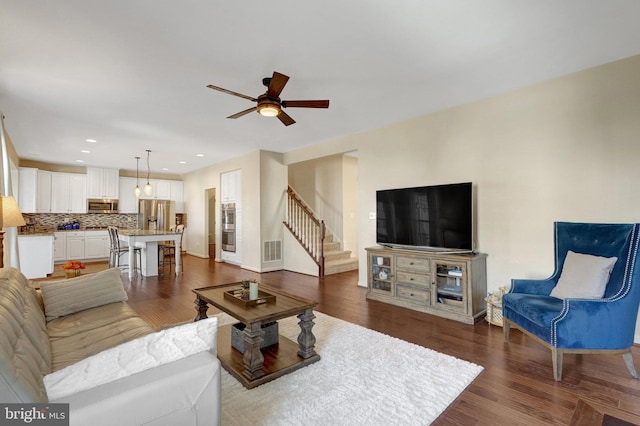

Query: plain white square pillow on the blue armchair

[550,251,618,299]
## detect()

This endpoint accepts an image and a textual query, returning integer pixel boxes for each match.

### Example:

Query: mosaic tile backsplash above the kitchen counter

[22,213,137,232]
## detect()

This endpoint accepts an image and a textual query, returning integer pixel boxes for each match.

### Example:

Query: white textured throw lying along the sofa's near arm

[43,317,218,401]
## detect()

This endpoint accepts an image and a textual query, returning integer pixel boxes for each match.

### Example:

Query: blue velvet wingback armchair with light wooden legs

[502,222,640,381]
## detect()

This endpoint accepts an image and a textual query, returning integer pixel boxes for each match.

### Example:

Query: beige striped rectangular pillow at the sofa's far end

[40,268,127,321]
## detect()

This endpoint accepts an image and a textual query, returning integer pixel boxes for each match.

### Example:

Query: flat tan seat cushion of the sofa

[47,302,154,371]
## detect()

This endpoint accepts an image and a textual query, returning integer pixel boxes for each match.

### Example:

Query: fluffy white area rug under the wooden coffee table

[219,312,483,426]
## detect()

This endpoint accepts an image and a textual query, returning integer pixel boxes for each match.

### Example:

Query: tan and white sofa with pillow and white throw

[0,268,220,426]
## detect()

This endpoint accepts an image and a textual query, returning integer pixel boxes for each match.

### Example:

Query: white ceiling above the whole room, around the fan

[0,0,640,174]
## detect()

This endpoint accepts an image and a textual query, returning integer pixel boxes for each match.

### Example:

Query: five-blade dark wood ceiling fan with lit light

[207,71,329,126]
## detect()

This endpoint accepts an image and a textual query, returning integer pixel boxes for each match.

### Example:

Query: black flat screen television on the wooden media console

[376,182,474,253]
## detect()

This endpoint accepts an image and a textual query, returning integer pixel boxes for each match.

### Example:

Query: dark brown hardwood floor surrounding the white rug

[123,256,640,425]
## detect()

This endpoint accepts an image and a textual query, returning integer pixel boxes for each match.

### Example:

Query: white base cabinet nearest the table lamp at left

[18,234,53,279]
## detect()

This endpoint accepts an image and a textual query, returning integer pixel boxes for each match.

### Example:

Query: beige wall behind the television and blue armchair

[284,56,640,340]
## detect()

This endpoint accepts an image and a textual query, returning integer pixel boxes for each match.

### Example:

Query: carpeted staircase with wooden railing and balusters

[284,187,358,277]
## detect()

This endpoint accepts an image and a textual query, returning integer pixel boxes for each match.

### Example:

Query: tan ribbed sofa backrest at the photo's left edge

[0,267,51,402]
